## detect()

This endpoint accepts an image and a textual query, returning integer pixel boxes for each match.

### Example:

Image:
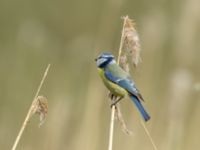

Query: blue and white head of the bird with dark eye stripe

[95,53,116,68]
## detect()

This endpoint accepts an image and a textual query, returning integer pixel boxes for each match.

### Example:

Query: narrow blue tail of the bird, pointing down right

[130,95,150,121]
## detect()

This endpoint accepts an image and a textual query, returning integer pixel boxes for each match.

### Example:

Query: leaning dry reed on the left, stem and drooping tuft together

[12,64,50,150]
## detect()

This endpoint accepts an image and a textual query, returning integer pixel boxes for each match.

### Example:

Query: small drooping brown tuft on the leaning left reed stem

[32,96,48,127]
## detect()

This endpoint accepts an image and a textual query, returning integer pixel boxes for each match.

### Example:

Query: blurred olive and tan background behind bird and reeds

[0,0,200,150]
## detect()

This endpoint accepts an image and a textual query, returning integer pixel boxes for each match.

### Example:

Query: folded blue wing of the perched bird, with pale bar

[105,70,143,100]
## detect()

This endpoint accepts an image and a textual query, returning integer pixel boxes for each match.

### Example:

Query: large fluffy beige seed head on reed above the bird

[122,16,140,67]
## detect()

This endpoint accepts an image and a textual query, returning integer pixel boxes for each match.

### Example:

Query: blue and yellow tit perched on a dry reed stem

[95,52,150,121]
